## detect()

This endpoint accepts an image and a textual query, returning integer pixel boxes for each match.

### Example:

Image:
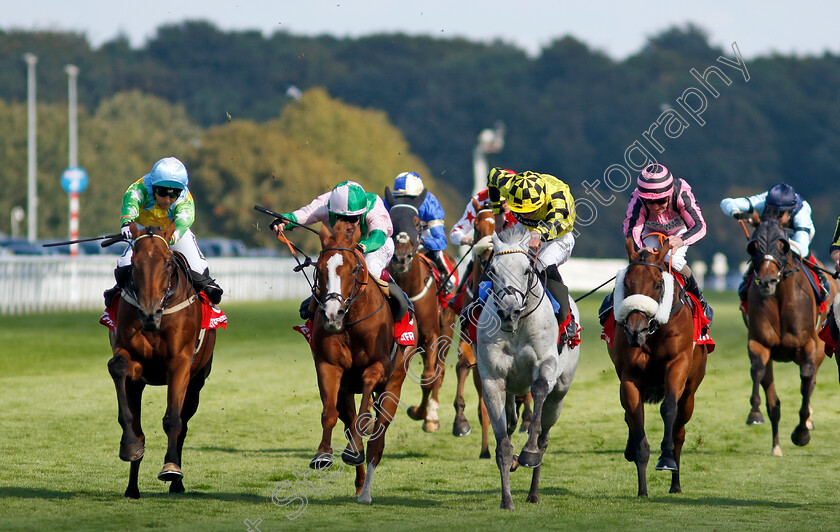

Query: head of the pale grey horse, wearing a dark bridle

[486,225,538,332]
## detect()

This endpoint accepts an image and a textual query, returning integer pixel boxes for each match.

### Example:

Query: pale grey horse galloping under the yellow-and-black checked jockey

[475,225,580,510]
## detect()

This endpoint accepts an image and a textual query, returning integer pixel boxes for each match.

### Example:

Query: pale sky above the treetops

[0,0,840,60]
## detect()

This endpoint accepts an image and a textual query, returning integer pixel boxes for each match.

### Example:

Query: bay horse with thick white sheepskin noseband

[607,238,708,497]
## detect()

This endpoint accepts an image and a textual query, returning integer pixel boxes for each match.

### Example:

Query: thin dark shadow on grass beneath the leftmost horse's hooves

[0,486,271,504]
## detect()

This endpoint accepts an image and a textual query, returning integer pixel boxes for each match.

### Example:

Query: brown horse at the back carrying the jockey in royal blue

[385,187,457,432]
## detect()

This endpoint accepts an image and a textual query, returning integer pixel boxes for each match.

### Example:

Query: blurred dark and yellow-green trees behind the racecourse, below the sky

[0,21,840,259]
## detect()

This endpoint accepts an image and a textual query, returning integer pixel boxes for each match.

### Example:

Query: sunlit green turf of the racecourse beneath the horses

[0,295,840,531]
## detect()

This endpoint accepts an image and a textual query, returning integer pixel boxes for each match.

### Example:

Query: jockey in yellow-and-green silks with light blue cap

[115,157,222,303]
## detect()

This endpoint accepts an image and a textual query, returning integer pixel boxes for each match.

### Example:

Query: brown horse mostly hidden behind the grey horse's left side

[452,198,532,458]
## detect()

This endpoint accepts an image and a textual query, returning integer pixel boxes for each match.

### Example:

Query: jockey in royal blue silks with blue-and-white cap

[386,172,455,294]
